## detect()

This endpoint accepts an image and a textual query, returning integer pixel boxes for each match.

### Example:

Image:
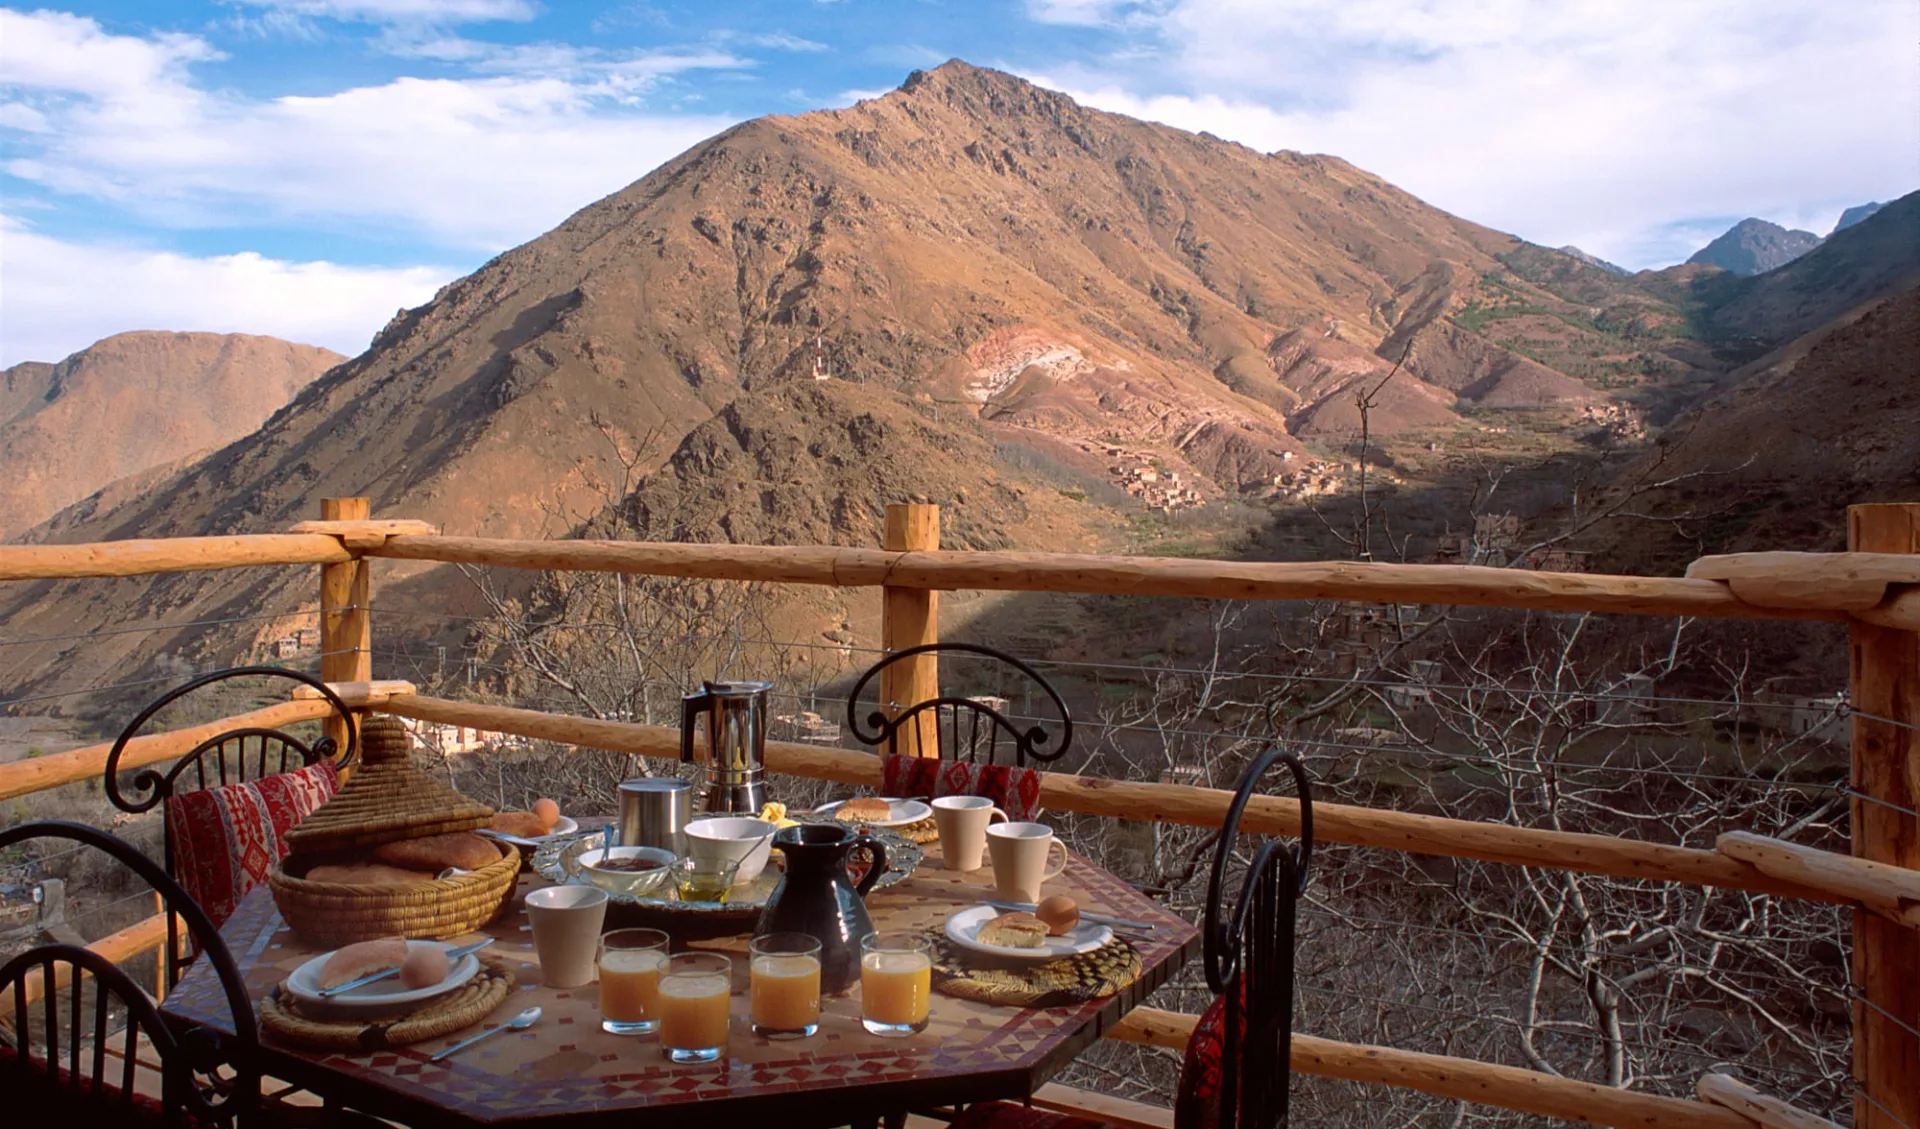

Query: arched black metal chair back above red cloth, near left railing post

[106,666,359,913]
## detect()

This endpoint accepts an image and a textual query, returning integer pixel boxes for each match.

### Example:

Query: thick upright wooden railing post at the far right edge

[1847,503,1920,1129]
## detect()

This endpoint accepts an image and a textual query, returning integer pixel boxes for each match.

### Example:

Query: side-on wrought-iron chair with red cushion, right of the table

[954,747,1313,1129]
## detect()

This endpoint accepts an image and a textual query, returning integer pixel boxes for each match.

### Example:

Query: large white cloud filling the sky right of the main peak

[1033,0,1920,267]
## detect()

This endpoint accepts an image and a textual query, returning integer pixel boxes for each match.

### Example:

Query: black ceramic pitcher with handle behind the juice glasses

[753,824,887,995]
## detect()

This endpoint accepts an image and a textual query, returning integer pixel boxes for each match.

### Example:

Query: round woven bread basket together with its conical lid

[267,716,520,947]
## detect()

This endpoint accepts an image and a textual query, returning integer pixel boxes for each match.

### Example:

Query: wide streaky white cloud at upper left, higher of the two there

[0,10,739,252]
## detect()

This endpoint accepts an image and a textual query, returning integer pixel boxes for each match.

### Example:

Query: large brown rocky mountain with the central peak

[0,61,1781,685]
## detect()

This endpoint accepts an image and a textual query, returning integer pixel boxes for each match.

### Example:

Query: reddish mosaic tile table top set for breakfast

[163,845,1198,1129]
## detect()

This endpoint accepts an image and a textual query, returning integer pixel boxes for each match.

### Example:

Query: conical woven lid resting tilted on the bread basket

[286,714,493,853]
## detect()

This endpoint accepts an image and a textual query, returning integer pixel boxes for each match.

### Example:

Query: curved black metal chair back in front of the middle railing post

[847,643,1073,768]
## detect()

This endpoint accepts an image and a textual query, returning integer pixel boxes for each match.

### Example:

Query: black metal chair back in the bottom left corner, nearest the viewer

[0,820,259,1125]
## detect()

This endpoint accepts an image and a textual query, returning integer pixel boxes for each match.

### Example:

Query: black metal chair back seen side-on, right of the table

[1202,747,1313,1129]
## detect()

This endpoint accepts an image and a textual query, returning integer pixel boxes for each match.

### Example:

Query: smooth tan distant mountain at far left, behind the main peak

[0,332,346,538]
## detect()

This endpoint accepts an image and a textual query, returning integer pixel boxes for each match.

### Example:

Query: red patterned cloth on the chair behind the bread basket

[167,760,340,925]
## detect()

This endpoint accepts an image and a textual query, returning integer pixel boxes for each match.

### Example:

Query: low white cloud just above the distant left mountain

[0,217,459,367]
